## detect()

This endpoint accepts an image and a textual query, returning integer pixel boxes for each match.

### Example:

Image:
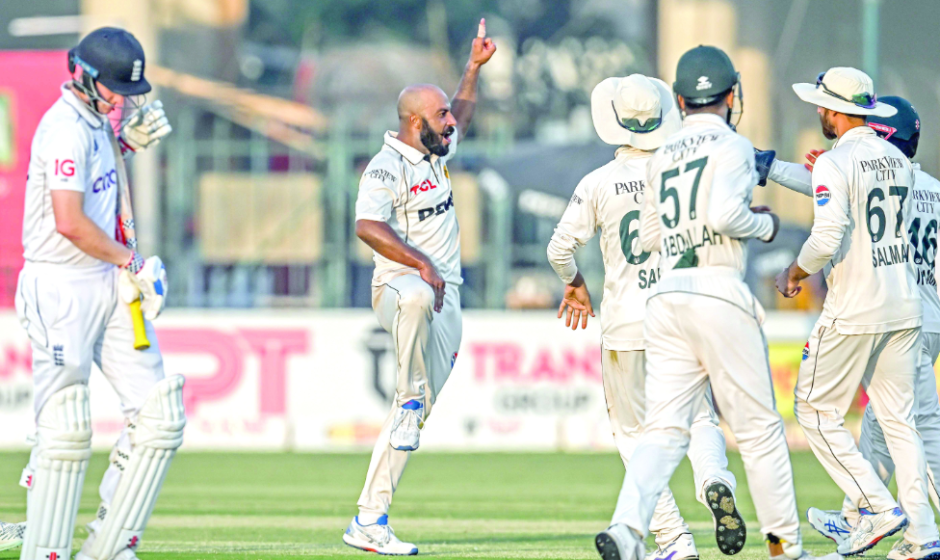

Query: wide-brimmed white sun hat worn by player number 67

[793,67,898,117]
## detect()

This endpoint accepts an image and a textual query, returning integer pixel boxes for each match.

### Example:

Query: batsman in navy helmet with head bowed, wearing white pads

[16,27,186,560]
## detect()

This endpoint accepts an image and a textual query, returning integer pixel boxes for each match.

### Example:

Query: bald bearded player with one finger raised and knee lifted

[343,20,496,555]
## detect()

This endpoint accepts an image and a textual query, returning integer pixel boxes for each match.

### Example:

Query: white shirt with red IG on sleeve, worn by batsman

[23,85,119,268]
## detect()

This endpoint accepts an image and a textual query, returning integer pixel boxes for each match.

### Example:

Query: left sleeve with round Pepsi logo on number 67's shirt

[797,154,850,274]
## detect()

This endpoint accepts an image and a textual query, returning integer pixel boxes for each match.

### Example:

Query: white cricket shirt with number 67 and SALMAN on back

[797,125,925,334]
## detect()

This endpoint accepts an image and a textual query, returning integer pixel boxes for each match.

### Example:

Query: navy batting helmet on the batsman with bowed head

[69,27,152,95]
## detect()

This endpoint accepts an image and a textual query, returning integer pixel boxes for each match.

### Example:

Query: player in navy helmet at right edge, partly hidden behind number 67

[758,88,940,560]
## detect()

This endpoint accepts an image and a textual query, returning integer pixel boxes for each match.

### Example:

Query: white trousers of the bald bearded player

[359,274,463,524]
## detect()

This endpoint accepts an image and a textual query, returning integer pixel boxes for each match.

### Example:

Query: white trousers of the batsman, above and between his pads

[15,262,164,504]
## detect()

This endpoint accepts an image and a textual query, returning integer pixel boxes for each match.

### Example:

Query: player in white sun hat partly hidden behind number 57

[548,74,746,560]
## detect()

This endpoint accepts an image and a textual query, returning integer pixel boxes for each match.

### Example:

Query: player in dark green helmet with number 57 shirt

[595,46,836,560]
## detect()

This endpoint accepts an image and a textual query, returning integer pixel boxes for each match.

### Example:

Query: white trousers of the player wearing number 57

[614,292,802,544]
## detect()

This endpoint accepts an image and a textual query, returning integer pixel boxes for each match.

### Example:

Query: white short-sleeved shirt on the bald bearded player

[356,132,463,286]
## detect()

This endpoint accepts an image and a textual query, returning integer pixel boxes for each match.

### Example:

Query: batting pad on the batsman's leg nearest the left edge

[20,385,91,560]
